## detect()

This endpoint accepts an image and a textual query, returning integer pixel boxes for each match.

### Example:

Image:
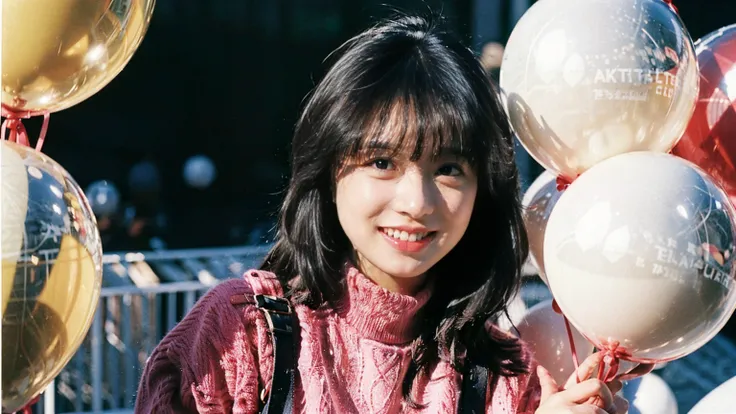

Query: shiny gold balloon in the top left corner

[2,0,155,115]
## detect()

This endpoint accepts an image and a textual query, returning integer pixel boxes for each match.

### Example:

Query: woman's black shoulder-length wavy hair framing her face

[262,15,528,404]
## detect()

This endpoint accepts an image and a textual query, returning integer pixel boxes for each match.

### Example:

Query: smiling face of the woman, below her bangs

[335,110,478,294]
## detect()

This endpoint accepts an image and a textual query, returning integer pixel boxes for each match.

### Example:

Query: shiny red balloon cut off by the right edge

[672,24,736,201]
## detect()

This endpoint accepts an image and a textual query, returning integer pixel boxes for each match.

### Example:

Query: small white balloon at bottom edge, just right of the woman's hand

[623,374,680,414]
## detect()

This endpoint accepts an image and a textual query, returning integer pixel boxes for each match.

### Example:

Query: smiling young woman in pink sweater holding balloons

[136,12,648,414]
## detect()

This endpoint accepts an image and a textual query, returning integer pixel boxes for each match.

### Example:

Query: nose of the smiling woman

[393,171,438,219]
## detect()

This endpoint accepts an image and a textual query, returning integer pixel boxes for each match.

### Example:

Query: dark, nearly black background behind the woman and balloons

[15,0,736,251]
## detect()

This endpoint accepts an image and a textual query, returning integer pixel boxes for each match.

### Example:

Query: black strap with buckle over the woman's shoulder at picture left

[253,295,299,414]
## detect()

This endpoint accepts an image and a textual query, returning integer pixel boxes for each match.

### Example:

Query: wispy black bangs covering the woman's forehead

[333,41,485,168]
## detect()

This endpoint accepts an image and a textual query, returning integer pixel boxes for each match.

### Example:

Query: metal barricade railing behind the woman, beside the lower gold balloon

[34,246,270,414]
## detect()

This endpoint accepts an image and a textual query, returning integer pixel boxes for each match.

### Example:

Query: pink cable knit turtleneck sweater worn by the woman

[135,268,540,414]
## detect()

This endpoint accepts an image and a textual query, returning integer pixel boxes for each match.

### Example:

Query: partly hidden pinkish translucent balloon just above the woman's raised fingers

[516,300,593,385]
